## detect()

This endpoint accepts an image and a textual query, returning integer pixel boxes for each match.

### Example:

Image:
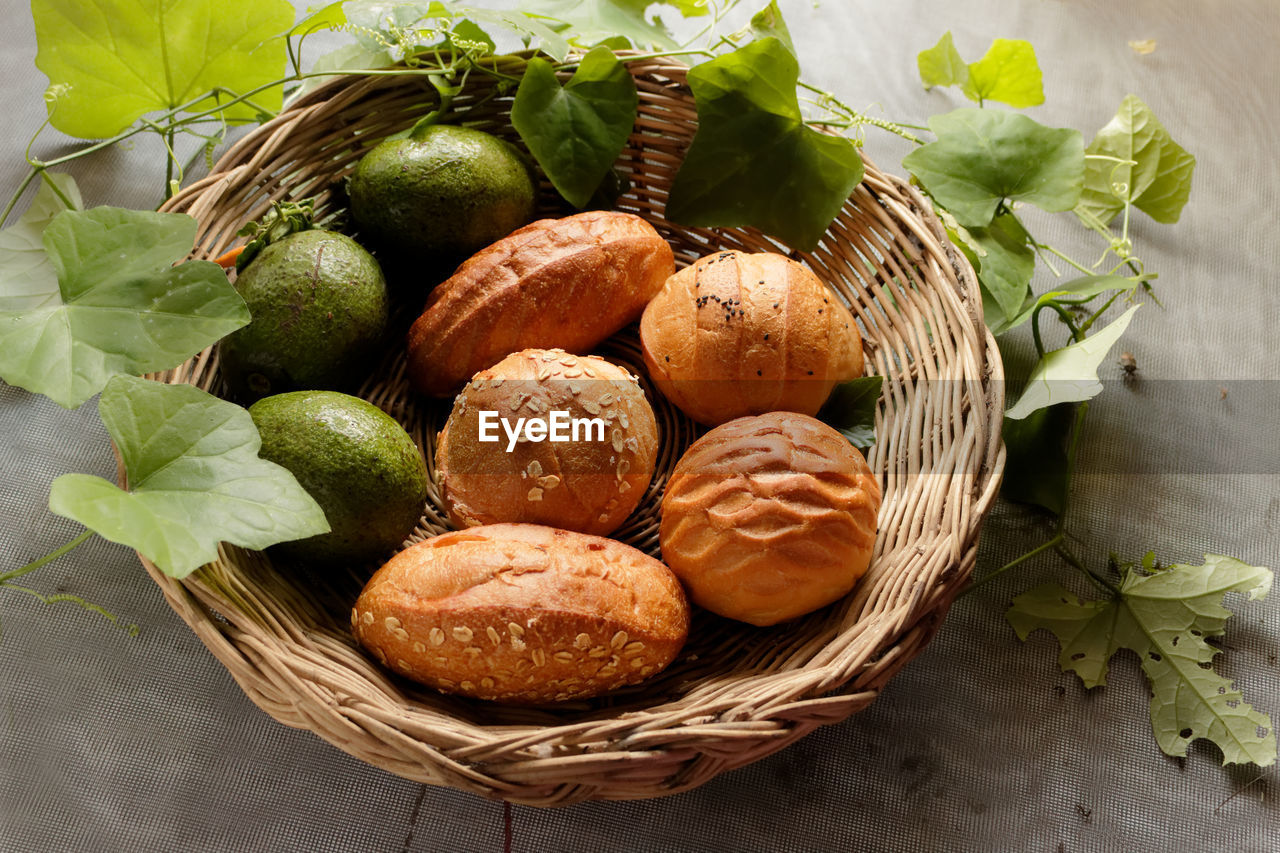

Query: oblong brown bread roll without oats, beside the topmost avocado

[408,210,675,396]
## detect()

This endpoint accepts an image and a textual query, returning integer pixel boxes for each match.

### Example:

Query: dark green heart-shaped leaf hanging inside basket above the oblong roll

[511,47,639,207]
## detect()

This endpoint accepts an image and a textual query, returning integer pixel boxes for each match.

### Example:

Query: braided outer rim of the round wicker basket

[142,51,1005,806]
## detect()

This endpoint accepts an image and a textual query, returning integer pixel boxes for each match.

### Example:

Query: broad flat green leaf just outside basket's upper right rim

[902,108,1084,228]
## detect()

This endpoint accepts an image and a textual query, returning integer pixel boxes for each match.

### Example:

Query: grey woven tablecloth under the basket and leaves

[0,0,1280,853]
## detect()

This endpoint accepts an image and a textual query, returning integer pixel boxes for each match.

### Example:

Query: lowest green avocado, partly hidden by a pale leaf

[248,391,428,570]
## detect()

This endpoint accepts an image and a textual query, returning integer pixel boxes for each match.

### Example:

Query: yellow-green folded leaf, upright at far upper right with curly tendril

[1076,95,1196,224]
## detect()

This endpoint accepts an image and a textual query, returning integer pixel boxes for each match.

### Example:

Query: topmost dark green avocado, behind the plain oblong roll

[347,124,538,269]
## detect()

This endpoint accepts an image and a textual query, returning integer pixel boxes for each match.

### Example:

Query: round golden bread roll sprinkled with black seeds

[640,251,863,427]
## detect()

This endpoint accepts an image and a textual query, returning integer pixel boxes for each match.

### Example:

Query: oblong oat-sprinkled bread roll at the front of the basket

[351,524,689,704]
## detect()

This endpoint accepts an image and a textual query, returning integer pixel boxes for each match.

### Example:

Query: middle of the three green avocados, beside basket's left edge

[218,229,389,400]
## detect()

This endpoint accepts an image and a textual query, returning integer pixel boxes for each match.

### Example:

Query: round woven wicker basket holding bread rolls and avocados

[143,58,1004,806]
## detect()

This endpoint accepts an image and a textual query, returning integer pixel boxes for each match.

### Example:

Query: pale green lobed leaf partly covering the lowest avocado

[49,377,329,578]
